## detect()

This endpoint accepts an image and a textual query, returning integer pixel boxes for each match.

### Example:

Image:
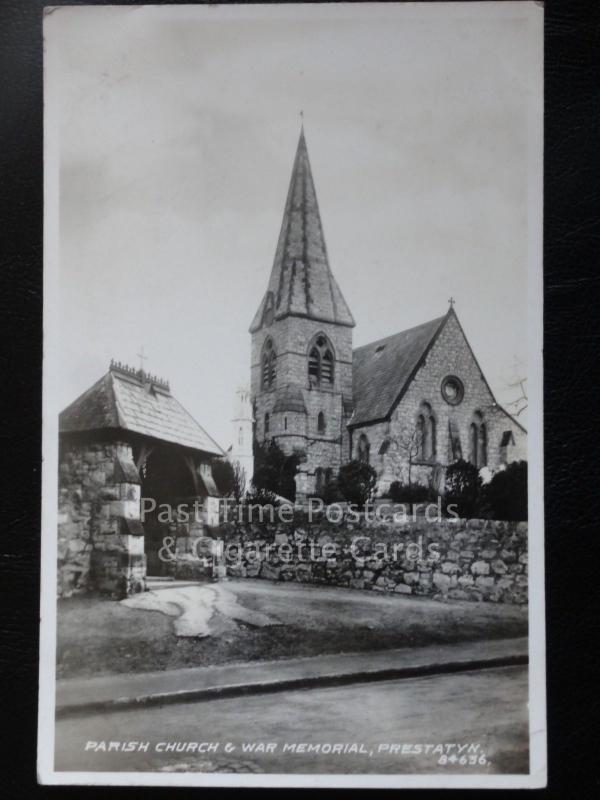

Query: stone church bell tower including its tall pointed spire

[250,129,355,494]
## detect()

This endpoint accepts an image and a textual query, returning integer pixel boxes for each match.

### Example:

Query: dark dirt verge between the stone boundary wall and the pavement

[57,580,527,678]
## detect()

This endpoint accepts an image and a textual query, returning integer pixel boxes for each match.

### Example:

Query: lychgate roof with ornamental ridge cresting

[59,364,224,456]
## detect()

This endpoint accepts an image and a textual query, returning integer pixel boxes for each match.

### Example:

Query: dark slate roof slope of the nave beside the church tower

[349,314,448,425]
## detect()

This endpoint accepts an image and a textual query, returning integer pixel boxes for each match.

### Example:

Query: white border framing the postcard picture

[38,1,546,788]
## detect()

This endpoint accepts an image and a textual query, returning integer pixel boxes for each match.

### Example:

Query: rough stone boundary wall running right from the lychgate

[213,520,528,604]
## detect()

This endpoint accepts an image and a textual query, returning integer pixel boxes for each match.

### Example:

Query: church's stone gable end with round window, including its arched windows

[352,309,526,488]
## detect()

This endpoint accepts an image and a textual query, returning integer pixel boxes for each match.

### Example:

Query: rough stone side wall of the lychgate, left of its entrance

[58,441,146,597]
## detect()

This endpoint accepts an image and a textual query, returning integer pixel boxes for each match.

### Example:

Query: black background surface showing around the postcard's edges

[0,0,600,798]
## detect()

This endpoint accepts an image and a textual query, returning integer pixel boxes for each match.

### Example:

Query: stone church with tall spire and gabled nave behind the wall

[250,130,527,497]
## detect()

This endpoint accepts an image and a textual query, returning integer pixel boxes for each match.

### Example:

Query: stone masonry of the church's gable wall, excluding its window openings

[352,315,527,492]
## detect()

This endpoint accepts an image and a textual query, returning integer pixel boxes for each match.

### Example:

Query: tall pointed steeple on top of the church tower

[250,126,354,333]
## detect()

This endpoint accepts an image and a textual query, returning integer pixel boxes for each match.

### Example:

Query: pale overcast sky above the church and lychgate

[46,3,540,447]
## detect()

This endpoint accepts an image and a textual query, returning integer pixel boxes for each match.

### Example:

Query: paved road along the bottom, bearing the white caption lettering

[56,667,528,774]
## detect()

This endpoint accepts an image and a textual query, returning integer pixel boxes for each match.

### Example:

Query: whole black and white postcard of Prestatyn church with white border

[38,2,546,788]
